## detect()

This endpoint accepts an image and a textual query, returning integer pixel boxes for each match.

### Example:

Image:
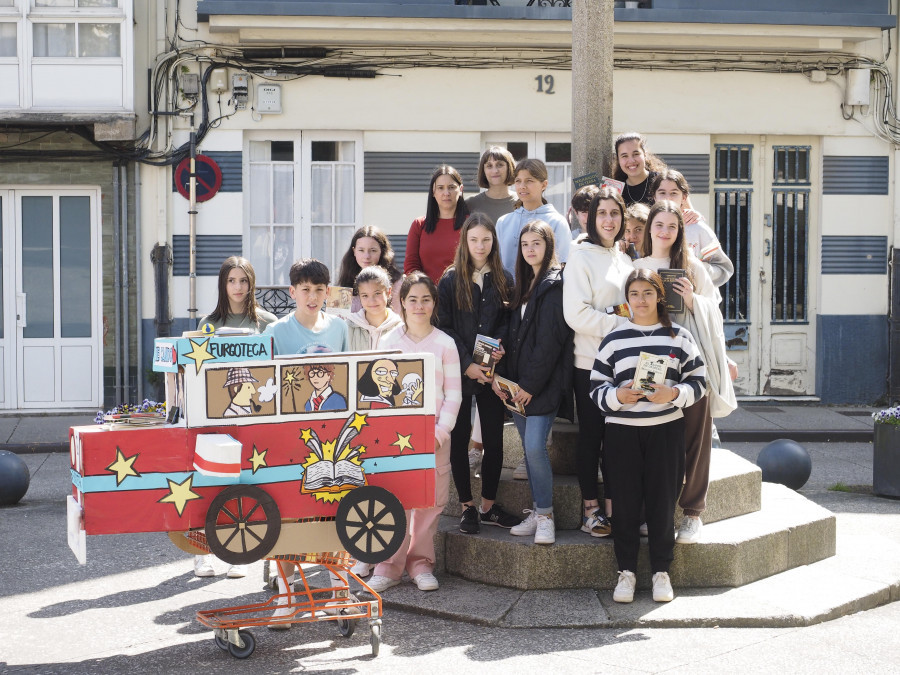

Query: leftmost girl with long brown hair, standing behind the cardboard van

[194,255,277,579]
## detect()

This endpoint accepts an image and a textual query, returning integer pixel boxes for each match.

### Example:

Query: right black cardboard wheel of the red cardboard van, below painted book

[335,485,406,564]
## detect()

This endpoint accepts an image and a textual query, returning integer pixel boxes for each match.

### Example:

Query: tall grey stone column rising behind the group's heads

[572,0,614,178]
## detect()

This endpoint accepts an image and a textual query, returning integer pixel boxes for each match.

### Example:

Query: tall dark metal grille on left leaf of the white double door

[715,188,753,323]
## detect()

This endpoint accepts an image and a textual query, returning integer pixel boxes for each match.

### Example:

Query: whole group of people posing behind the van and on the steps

[195,133,737,612]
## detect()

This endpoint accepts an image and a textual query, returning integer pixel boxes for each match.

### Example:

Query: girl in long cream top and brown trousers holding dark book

[634,200,737,544]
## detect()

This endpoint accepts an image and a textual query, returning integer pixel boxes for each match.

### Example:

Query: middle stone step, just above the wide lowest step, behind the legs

[444,448,762,530]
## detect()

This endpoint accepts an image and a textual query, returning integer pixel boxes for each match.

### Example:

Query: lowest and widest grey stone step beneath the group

[436,483,835,590]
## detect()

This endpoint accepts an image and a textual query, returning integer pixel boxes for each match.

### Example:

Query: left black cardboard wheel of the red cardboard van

[205,485,281,565]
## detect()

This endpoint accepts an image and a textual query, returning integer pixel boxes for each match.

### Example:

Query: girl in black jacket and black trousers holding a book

[438,213,520,534]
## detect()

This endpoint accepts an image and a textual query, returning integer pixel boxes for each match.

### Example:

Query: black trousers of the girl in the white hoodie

[572,368,612,500]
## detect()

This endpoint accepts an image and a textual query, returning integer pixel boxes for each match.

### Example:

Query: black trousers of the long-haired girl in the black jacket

[450,388,505,503]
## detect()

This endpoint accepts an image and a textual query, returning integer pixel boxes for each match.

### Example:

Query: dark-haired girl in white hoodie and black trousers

[563,187,634,537]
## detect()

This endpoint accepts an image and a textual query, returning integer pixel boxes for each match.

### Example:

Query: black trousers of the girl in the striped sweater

[606,418,684,574]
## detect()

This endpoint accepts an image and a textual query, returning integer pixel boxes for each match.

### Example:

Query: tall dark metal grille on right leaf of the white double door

[771,188,809,323]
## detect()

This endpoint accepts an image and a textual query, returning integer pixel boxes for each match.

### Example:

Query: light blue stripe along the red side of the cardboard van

[72,455,434,494]
